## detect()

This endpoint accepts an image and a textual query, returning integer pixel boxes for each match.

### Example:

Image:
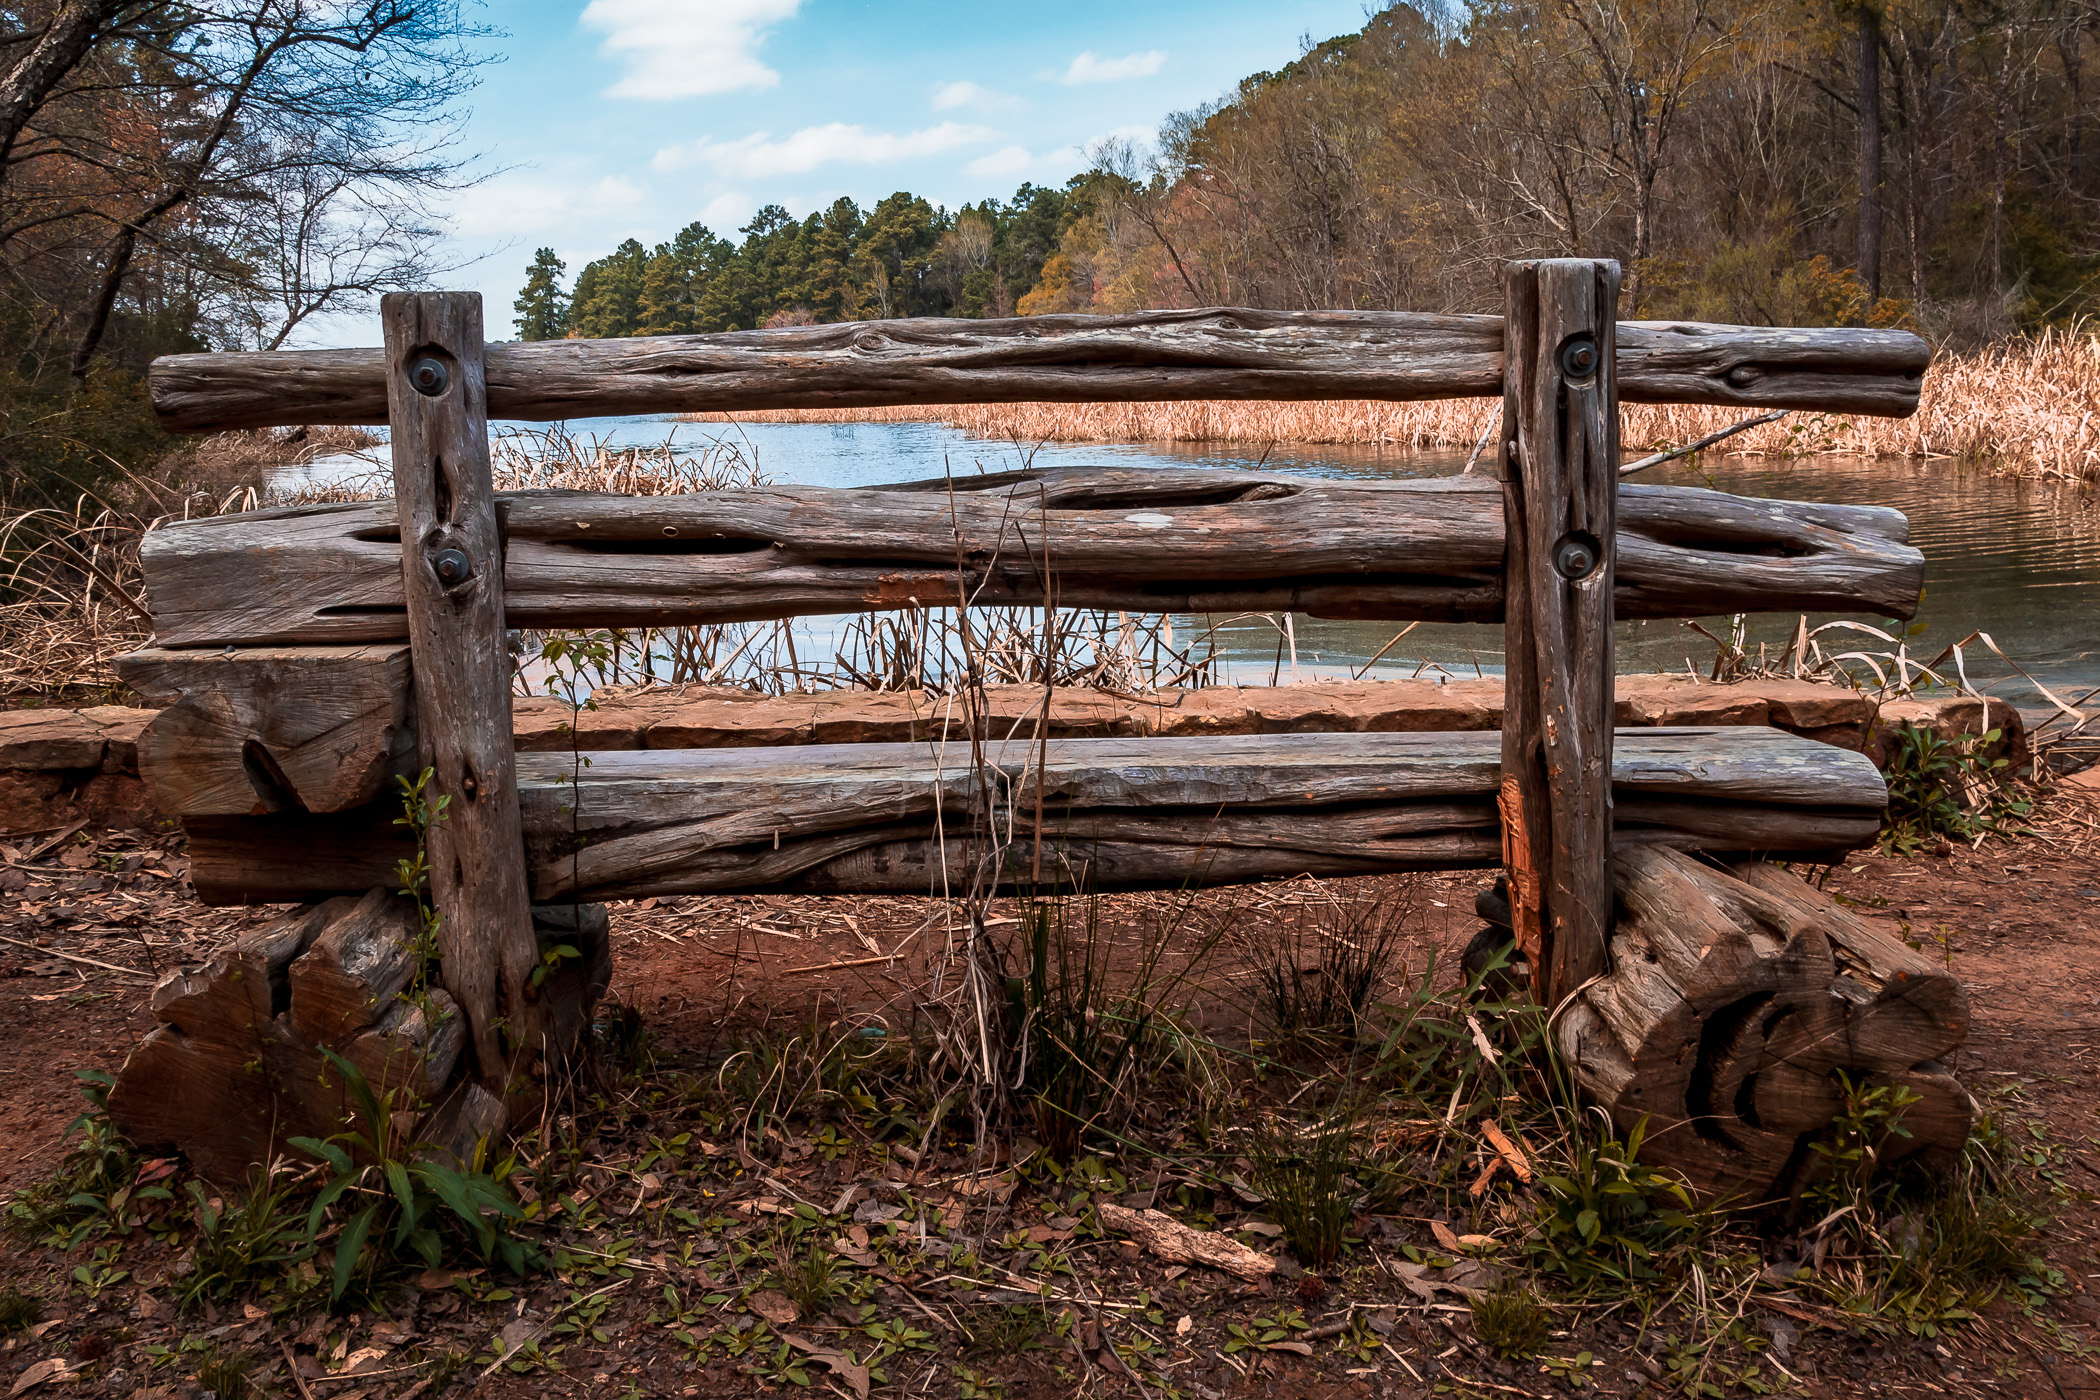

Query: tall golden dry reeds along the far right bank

[699,330,2100,481]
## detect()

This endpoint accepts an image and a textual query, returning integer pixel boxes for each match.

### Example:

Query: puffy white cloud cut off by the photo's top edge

[584,0,802,103]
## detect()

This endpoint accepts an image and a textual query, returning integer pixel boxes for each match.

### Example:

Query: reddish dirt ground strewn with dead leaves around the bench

[0,804,2100,1400]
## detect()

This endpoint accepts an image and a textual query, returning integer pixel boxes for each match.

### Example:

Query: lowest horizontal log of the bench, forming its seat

[185,728,1886,903]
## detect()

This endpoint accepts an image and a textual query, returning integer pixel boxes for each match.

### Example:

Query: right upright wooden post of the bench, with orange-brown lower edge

[1499,258,1619,1005]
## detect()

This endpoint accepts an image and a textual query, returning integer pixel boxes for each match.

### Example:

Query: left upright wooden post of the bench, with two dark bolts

[380,292,540,1098]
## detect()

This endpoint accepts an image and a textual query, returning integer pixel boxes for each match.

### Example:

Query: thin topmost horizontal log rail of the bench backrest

[149,306,1932,432]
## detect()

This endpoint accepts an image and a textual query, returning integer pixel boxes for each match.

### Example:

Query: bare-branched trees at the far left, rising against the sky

[0,0,487,503]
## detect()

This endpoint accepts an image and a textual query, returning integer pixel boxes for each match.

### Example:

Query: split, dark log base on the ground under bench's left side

[109,888,611,1186]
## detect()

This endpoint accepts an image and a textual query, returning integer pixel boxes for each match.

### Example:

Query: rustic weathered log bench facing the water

[111,260,1968,1190]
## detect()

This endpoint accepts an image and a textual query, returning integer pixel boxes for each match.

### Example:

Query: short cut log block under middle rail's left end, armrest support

[116,644,416,816]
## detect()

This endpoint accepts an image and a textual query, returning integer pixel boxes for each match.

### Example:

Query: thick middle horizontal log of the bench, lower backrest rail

[141,468,1924,646]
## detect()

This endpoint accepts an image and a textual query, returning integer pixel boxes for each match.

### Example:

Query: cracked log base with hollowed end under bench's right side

[1558,846,1972,1201]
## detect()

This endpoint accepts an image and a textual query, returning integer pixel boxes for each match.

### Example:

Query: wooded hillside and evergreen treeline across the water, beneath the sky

[517,0,2100,344]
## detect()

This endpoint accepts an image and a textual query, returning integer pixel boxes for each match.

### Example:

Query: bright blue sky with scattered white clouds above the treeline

[352,0,1365,344]
